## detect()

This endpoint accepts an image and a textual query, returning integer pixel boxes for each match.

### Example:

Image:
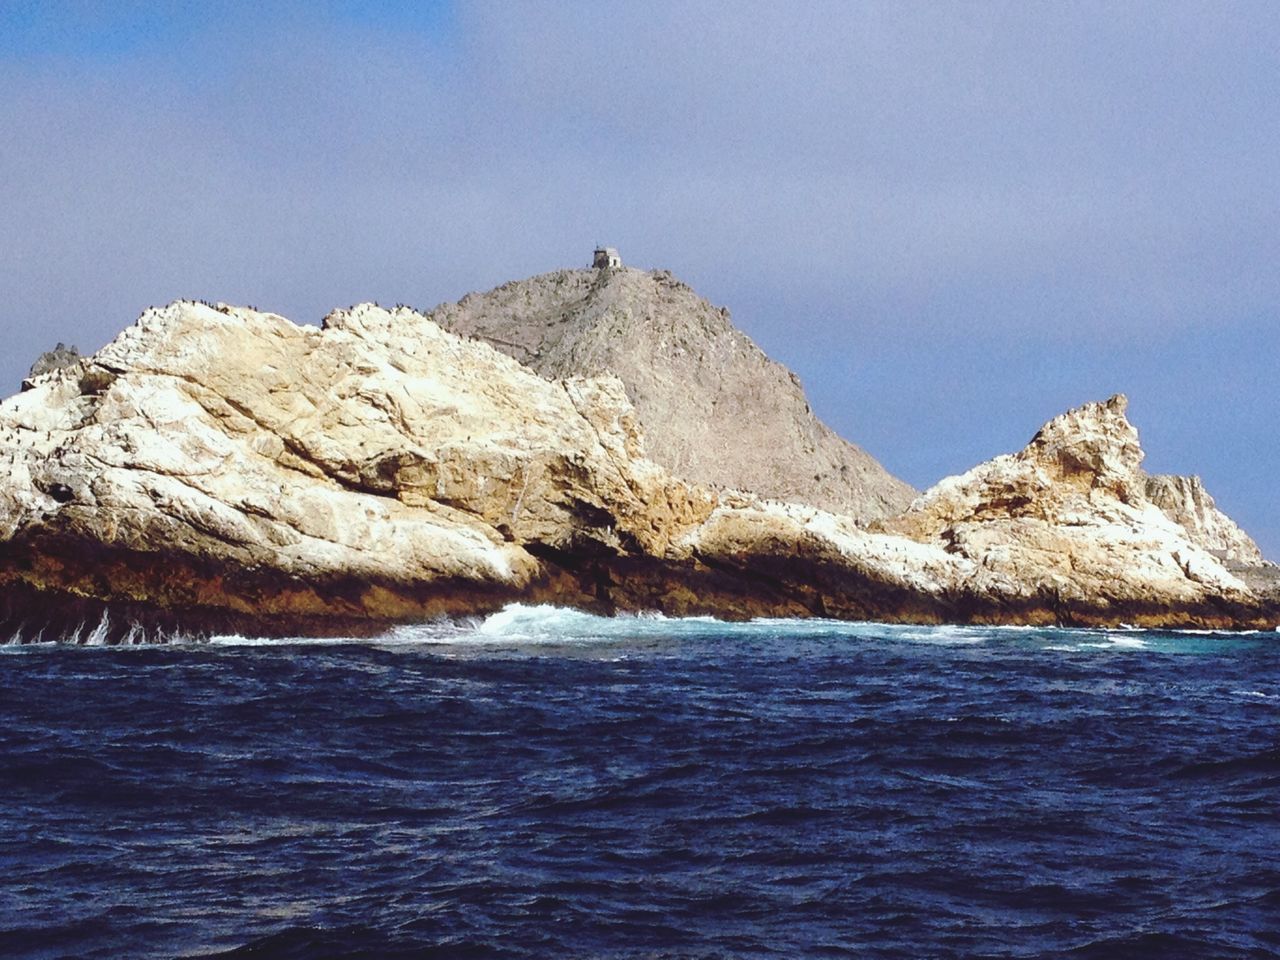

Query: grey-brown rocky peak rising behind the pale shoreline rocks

[429,268,915,520]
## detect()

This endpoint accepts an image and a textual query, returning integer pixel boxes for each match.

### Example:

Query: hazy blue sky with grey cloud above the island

[0,0,1280,559]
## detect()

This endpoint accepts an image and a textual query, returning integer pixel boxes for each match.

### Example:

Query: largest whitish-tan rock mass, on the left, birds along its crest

[0,302,709,640]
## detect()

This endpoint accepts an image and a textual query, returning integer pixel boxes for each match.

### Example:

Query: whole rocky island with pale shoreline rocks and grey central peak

[0,265,1280,641]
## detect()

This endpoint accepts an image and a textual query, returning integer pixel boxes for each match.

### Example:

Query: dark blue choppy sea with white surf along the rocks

[0,611,1280,959]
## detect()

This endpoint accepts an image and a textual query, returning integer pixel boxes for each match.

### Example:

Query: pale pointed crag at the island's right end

[882,396,1269,623]
